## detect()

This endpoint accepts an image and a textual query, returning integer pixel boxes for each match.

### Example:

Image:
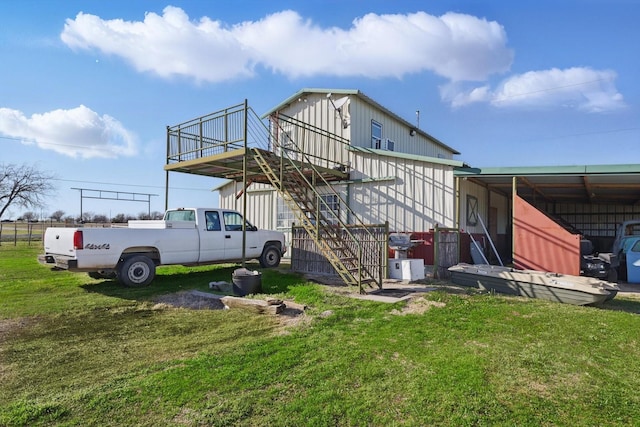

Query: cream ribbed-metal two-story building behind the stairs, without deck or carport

[217,89,463,237]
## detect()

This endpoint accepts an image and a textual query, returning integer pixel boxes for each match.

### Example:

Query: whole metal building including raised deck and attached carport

[165,89,640,281]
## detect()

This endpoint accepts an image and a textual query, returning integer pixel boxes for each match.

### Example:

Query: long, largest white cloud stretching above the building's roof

[60,6,513,82]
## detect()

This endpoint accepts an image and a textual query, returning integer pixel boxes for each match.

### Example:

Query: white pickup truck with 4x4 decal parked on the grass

[38,208,287,287]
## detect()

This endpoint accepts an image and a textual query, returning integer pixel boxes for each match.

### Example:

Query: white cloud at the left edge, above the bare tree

[0,105,137,158]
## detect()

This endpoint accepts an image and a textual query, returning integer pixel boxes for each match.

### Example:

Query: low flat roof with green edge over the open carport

[454,164,640,205]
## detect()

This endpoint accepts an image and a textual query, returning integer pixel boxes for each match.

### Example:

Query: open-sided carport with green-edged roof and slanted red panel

[454,164,640,274]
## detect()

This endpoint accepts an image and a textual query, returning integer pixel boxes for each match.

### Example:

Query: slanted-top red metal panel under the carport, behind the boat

[513,195,580,276]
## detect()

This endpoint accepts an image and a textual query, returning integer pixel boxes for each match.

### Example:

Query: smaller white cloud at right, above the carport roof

[441,67,625,113]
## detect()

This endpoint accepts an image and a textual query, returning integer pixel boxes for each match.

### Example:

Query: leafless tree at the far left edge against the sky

[0,163,55,218]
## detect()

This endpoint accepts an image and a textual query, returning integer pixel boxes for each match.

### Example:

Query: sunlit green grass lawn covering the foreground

[0,243,640,426]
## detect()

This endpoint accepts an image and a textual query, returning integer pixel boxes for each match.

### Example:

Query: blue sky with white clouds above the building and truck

[0,0,640,218]
